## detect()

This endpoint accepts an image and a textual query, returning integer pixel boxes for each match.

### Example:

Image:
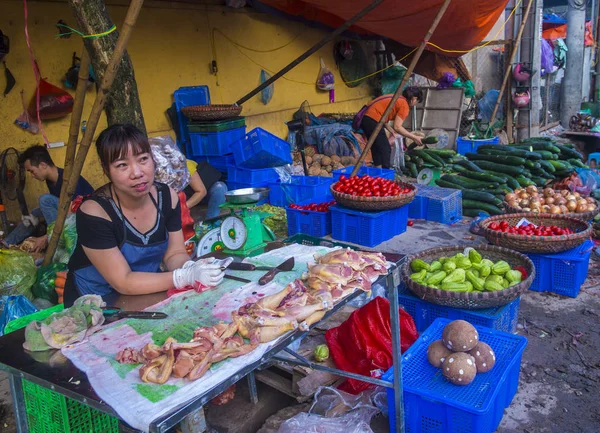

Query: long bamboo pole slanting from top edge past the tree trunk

[44,0,144,264]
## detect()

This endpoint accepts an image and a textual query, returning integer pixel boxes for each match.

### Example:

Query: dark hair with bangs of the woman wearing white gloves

[96,124,152,174]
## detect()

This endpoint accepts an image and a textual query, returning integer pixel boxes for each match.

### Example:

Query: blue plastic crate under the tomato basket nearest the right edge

[527,240,594,298]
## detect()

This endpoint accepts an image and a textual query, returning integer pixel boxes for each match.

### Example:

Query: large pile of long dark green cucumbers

[436,137,586,216]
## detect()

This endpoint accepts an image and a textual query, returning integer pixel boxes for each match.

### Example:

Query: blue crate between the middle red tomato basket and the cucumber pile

[408,185,462,224]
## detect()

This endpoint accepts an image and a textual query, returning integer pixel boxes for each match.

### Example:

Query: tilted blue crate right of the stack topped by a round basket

[231,128,292,168]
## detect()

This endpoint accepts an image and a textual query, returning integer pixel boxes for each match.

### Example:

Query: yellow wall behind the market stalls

[0,0,369,218]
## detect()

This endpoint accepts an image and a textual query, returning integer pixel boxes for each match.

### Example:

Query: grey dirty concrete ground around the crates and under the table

[0,220,600,433]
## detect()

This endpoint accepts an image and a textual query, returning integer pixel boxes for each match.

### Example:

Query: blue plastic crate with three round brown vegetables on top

[382,318,527,433]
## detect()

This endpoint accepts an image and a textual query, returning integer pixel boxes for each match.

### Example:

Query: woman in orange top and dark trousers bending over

[360,87,423,168]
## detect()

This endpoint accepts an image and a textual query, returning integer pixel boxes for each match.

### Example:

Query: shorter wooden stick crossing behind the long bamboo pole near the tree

[43,44,90,266]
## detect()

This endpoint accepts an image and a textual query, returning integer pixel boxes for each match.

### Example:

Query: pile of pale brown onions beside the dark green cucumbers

[504,185,598,214]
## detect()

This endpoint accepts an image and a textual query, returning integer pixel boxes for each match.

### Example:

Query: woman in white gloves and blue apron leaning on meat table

[65,125,223,307]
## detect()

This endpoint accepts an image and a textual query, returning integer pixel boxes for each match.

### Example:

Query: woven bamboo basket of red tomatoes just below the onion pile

[479,213,592,254]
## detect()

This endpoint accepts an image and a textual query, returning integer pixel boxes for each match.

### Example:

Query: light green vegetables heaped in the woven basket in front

[410,248,527,292]
